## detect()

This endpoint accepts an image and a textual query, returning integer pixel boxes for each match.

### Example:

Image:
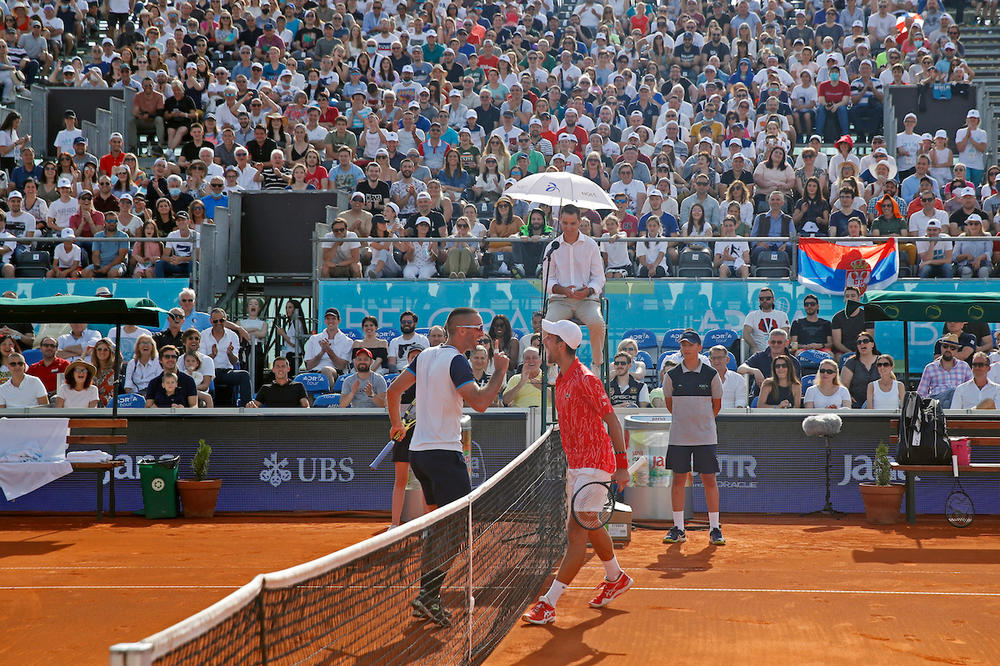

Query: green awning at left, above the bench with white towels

[0,296,165,326]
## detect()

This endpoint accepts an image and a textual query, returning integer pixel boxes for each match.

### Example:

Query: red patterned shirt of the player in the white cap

[556,359,615,473]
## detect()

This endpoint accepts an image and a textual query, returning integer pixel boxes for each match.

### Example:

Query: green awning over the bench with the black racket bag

[848,291,1000,322]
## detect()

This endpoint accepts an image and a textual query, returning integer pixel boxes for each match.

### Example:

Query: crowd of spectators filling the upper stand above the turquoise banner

[0,0,1000,278]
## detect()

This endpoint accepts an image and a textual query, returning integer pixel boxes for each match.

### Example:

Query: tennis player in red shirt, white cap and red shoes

[521,319,632,624]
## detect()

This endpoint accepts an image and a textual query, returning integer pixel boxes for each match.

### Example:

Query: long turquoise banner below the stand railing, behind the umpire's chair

[317,279,996,369]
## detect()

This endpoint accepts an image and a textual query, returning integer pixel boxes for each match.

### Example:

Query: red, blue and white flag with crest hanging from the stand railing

[799,238,899,294]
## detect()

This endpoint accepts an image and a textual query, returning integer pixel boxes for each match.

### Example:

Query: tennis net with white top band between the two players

[111,428,567,666]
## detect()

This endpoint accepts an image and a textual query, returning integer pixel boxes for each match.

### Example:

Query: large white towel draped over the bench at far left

[0,418,73,501]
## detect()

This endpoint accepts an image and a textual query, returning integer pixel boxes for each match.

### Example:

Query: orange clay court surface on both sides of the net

[0,516,1000,664]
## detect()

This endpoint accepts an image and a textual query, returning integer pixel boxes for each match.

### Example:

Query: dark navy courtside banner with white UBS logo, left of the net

[0,410,528,513]
